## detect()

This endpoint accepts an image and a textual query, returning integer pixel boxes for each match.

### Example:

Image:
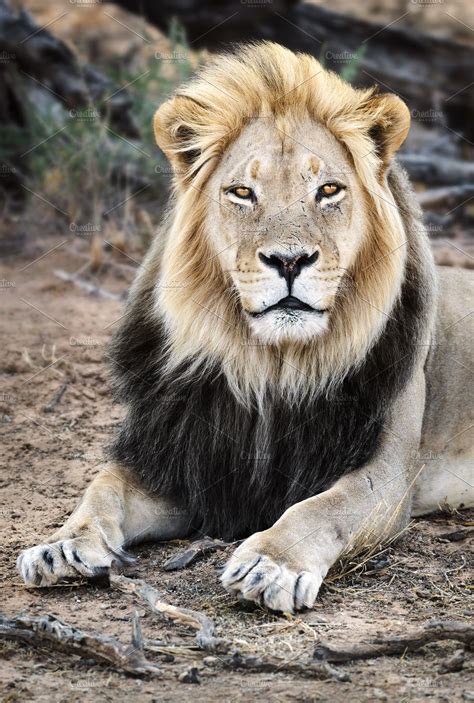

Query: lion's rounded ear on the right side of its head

[365,93,410,166]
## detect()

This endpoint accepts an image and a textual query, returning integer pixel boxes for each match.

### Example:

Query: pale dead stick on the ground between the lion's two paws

[110,573,229,652]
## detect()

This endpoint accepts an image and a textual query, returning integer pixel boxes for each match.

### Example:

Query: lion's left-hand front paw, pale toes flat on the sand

[17,537,123,586]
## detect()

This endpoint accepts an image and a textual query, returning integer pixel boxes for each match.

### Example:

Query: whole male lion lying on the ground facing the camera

[18,43,474,611]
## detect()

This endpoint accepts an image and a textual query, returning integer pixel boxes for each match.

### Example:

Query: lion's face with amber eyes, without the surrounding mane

[206,118,365,343]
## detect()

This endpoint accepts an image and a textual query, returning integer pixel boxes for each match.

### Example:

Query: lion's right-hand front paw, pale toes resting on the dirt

[221,545,322,613]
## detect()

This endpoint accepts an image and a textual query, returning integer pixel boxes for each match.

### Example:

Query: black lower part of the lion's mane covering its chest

[111,257,424,539]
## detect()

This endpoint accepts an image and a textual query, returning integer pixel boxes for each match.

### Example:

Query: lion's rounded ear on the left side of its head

[153,96,201,181]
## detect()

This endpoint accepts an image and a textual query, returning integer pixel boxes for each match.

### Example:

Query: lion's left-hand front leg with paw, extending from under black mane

[17,466,189,586]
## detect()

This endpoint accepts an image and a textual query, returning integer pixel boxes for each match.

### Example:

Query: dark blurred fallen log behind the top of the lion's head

[113,0,474,138]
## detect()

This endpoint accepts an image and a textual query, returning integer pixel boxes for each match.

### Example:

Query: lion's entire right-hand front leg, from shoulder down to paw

[221,378,424,612]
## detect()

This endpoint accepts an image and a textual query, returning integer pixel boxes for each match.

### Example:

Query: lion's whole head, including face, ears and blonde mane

[153,42,410,394]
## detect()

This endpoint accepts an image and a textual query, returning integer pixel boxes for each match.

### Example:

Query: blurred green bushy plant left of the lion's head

[0,23,199,258]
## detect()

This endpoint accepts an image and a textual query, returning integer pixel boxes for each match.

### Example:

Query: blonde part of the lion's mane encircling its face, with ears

[150,43,409,405]
